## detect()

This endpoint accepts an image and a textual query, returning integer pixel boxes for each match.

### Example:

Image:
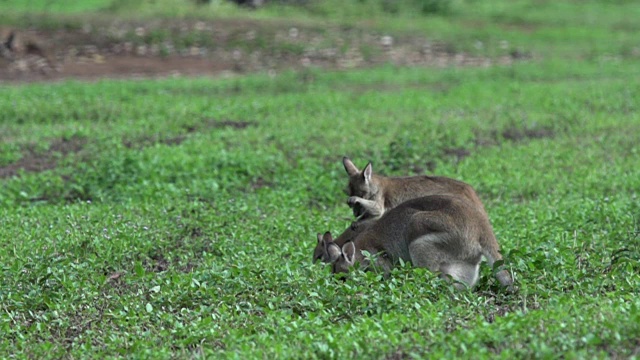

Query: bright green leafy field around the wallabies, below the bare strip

[0,2,640,359]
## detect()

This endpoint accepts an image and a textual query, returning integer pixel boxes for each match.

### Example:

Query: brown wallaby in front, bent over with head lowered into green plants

[322,195,513,288]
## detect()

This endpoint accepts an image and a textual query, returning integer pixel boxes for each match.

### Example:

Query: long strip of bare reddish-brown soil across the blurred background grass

[0,20,530,82]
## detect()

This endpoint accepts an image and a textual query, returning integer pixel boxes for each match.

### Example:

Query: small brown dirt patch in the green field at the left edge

[0,136,86,178]
